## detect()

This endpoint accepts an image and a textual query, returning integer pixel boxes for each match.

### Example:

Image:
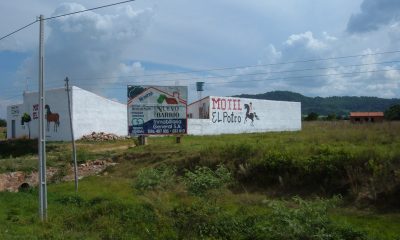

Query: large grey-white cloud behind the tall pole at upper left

[19,3,153,91]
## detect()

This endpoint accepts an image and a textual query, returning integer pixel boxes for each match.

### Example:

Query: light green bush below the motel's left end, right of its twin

[184,165,232,196]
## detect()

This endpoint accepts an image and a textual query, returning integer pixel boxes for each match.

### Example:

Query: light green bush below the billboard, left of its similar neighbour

[134,165,176,192]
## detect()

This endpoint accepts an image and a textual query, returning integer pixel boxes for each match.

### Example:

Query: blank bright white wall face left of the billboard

[72,87,128,139]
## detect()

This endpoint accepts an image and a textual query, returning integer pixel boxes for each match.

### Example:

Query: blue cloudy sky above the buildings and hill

[0,0,400,118]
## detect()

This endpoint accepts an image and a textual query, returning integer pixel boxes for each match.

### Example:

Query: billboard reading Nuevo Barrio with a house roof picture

[127,86,188,136]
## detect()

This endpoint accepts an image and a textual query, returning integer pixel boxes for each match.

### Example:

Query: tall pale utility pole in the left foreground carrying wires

[38,15,47,221]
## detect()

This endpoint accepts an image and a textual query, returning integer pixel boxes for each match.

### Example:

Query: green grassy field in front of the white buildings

[0,122,400,239]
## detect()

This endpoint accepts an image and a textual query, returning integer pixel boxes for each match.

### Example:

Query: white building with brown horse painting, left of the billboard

[7,86,128,141]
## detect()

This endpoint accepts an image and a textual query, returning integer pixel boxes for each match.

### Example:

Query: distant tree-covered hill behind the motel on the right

[235,91,400,115]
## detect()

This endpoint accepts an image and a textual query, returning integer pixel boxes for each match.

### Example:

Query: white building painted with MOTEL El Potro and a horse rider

[188,96,301,135]
